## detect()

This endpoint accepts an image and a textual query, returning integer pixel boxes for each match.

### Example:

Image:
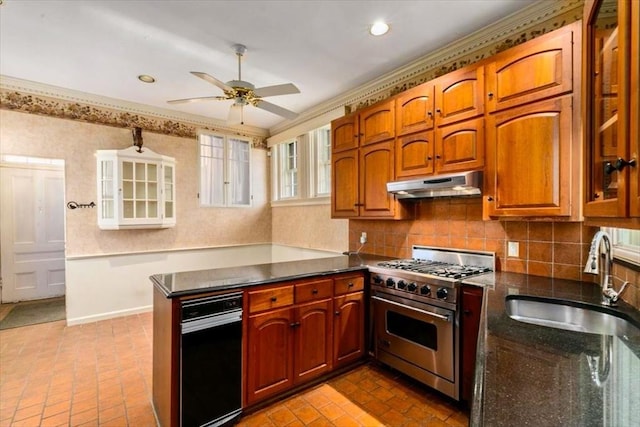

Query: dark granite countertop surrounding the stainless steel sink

[465,273,640,427]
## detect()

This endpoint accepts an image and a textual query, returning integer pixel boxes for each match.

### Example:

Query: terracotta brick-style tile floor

[0,313,468,427]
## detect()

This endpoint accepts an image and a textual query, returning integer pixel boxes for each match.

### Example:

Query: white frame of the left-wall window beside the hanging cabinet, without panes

[197,131,253,208]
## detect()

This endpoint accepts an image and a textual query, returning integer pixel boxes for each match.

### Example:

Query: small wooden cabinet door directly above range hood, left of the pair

[395,130,434,179]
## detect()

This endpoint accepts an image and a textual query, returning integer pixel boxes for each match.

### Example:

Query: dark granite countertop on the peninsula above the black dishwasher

[150,254,390,298]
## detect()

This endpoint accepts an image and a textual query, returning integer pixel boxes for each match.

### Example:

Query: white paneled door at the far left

[0,164,65,302]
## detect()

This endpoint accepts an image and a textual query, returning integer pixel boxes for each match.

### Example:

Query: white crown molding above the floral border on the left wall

[0,75,269,138]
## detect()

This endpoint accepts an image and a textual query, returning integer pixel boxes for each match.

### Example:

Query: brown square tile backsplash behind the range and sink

[349,198,640,307]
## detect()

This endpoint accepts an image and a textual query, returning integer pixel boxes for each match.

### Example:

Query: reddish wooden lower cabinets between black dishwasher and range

[245,273,365,405]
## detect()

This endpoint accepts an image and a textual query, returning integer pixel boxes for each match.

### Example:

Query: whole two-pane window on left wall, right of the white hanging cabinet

[198,133,251,207]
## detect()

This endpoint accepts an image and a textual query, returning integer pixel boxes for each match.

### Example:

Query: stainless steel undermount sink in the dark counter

[505,295,640,336]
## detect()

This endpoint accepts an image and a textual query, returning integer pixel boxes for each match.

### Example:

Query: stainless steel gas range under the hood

[369,246,495,400]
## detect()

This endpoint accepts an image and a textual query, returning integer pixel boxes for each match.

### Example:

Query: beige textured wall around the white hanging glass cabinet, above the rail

[0,110,271,257]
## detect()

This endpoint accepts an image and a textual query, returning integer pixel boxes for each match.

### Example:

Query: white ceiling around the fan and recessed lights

[0,0,536,129]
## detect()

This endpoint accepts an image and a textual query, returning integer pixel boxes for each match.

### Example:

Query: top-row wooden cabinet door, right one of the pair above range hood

[433,66,484,126]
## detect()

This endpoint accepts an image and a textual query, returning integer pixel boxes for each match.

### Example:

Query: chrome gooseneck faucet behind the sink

[584,231,629,306]
